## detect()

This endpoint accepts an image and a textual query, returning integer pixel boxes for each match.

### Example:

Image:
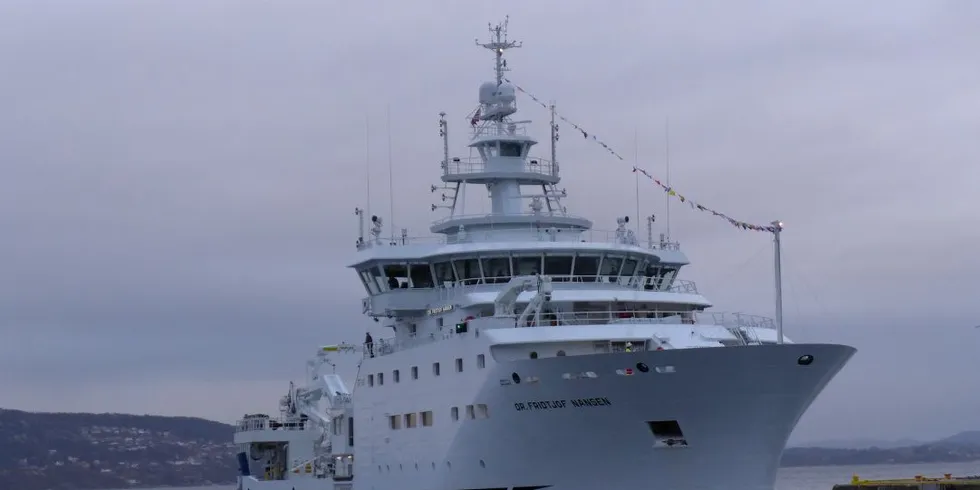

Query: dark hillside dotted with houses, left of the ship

[0,409,236,490]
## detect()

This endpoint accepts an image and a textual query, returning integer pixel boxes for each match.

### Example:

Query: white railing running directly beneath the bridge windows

[439,274,701,294]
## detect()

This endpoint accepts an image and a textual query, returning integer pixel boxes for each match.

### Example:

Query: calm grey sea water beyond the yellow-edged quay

[136,462,980,490]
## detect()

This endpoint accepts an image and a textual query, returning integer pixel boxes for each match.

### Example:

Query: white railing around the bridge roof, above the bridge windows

[357,223,680,251]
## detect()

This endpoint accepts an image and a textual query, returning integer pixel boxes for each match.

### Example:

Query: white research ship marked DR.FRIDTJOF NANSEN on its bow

[234,17,855,490]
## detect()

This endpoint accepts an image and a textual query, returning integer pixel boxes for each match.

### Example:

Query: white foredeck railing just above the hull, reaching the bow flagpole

[364,309,776,357]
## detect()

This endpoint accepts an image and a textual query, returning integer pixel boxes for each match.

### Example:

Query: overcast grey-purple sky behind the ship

[0,0,980,441]
